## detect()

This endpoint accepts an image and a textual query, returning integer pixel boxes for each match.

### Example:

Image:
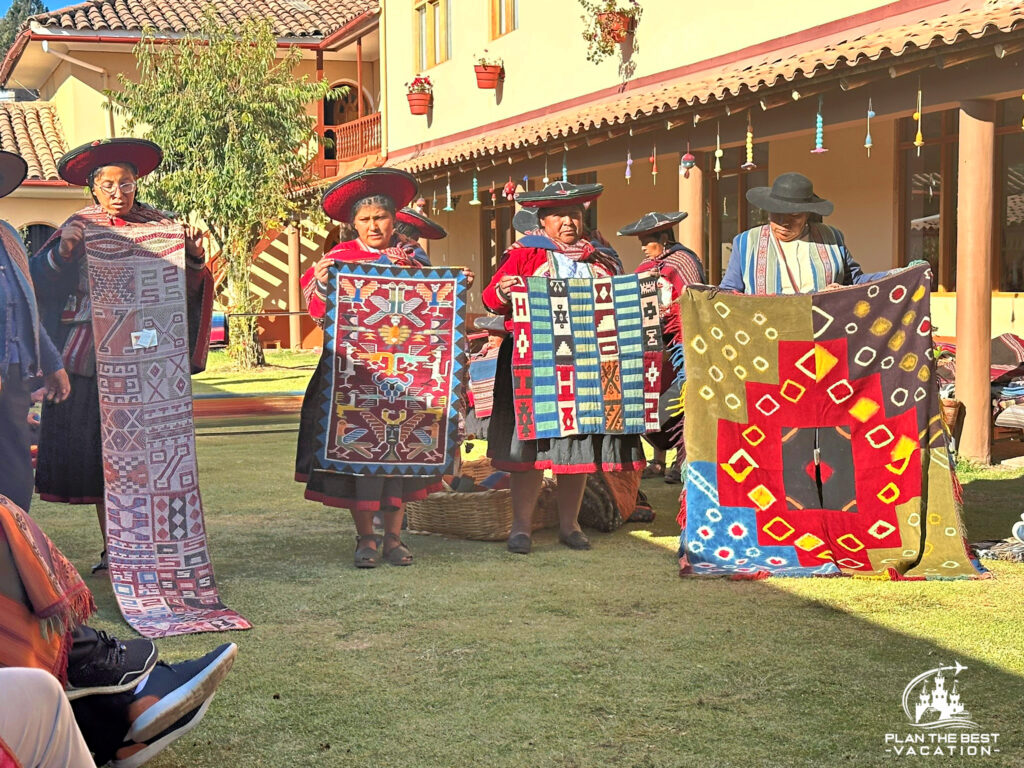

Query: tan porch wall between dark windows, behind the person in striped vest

[768,120,898,272]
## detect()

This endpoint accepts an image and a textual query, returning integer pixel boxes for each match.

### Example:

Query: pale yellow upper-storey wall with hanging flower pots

[384,0,888,153]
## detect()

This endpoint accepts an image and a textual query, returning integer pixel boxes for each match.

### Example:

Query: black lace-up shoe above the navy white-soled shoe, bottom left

[65,627,158,701]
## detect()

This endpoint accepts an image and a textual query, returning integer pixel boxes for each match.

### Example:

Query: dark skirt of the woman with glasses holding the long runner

[36,374,103,504]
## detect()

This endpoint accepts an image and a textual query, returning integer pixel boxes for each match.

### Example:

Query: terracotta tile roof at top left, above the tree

[31,0,380,37]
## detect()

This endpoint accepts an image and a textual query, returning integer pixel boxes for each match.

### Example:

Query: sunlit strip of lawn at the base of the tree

[193,349,319,395]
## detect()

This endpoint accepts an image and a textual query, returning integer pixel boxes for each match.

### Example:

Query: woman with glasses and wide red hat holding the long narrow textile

[32,138,213,570]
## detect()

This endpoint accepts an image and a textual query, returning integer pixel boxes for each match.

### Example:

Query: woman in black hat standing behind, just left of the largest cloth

[618,211,705,484]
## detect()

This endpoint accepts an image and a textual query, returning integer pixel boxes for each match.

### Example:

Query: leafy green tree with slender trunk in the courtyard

[112,10,339,368]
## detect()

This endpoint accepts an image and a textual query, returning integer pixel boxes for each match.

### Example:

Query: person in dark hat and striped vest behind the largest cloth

[721,173,886,296]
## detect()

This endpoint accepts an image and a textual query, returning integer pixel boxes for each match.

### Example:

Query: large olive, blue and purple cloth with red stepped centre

[680,267,986,579]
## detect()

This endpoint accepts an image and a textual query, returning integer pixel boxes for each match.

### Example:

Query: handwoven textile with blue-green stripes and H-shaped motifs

[511,272,663,440]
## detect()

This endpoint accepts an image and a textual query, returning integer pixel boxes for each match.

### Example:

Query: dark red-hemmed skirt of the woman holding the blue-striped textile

[487,336,647,474]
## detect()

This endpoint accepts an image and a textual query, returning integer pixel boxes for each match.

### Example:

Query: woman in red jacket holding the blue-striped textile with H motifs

[483,181,646,554]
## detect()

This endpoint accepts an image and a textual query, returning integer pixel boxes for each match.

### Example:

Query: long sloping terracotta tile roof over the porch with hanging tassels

[389,0,1024,172]
